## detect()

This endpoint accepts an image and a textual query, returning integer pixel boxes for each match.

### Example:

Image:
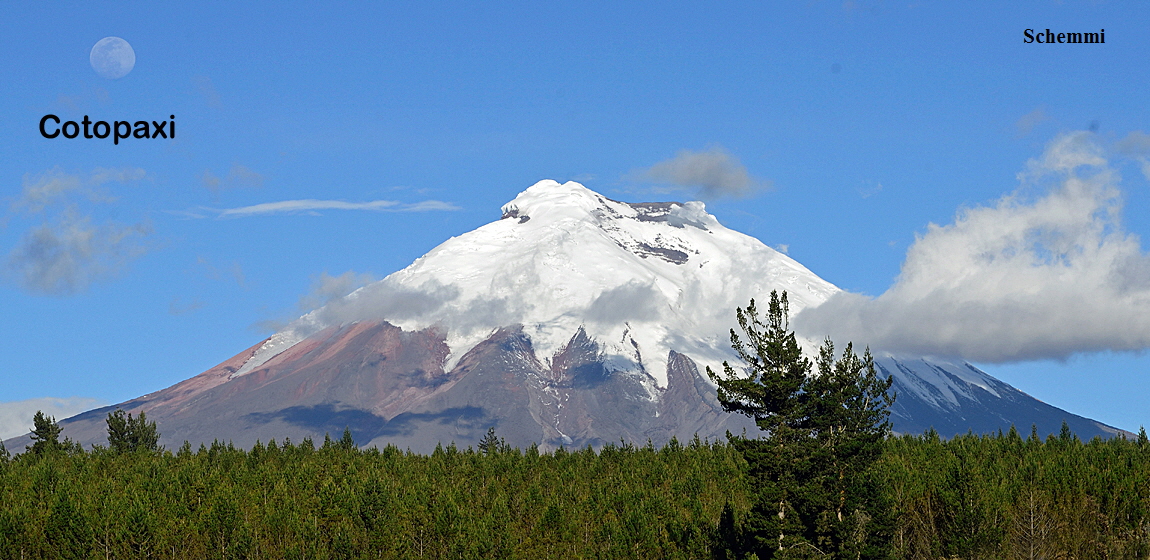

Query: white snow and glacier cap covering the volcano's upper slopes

[232,181,838,388]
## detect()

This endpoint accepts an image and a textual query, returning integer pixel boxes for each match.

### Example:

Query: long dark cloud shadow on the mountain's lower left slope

[245,405,492,442]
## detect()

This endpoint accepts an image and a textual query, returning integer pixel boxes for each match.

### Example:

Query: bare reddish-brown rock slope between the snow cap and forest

[17,322,753,452]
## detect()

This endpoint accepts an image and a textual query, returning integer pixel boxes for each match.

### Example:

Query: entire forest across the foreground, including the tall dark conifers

[0,292,1150,560]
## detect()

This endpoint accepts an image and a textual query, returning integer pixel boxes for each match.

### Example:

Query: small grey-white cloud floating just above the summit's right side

[637,146,769,198]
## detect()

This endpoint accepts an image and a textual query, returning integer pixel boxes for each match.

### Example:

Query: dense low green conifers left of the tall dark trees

[0,413,748,559]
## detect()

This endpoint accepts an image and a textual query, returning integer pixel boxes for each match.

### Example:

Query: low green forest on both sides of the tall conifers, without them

[0,416,1150,559]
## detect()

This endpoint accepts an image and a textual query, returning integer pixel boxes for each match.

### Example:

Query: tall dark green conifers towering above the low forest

[707,292,894,559]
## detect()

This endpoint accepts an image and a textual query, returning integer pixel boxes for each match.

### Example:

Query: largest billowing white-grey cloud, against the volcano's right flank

[794,132,1150,362]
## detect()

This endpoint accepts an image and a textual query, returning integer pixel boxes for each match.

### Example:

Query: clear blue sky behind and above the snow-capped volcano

[0,1,1150,439]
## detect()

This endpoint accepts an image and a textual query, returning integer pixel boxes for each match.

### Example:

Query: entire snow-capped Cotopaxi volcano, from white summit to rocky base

[4,181,1119,452]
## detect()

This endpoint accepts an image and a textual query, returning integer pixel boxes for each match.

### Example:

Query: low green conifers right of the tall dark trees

[876,424,1150,559]
